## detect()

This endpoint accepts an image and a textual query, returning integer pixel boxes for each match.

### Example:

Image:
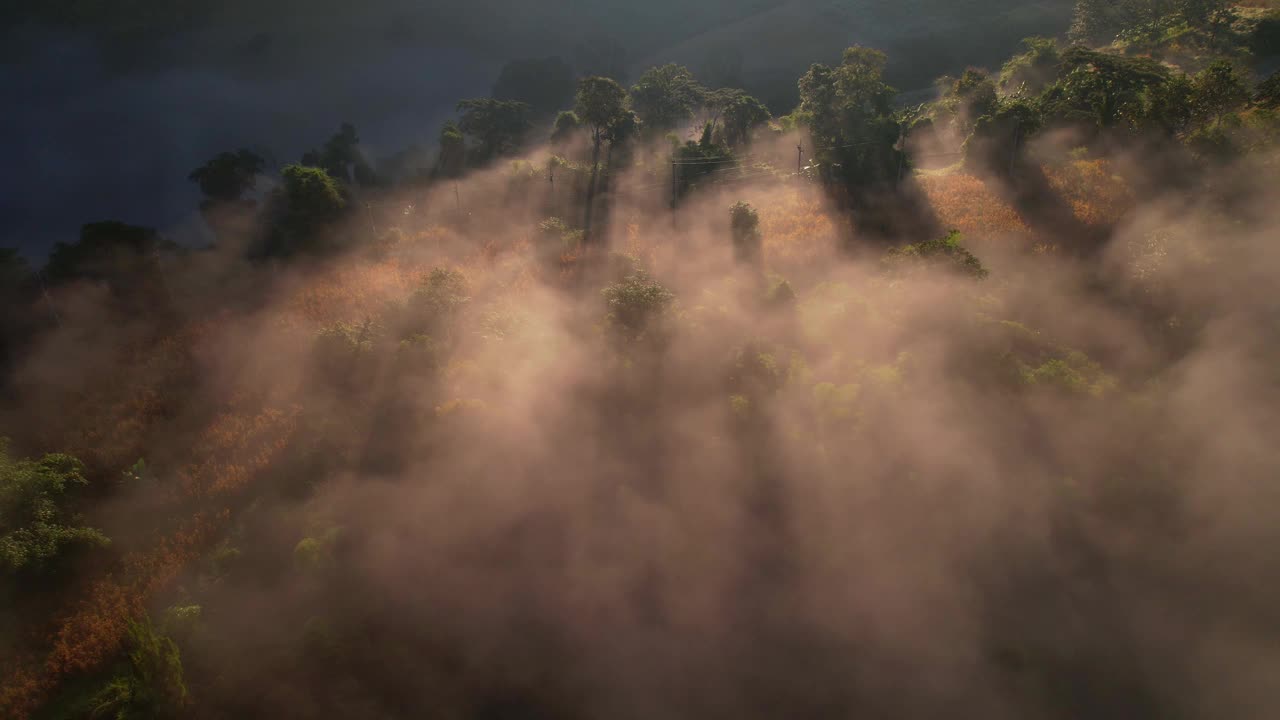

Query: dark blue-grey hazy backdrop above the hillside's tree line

[0,0,1070,258]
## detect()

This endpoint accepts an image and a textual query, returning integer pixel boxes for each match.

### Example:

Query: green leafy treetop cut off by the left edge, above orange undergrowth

[0,439,110,574]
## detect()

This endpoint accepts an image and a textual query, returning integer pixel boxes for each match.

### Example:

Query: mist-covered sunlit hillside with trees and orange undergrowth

[0,0,1280,720]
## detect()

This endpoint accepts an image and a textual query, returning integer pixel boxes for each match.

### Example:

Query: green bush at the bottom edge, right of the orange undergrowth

[90,618,187,720]
